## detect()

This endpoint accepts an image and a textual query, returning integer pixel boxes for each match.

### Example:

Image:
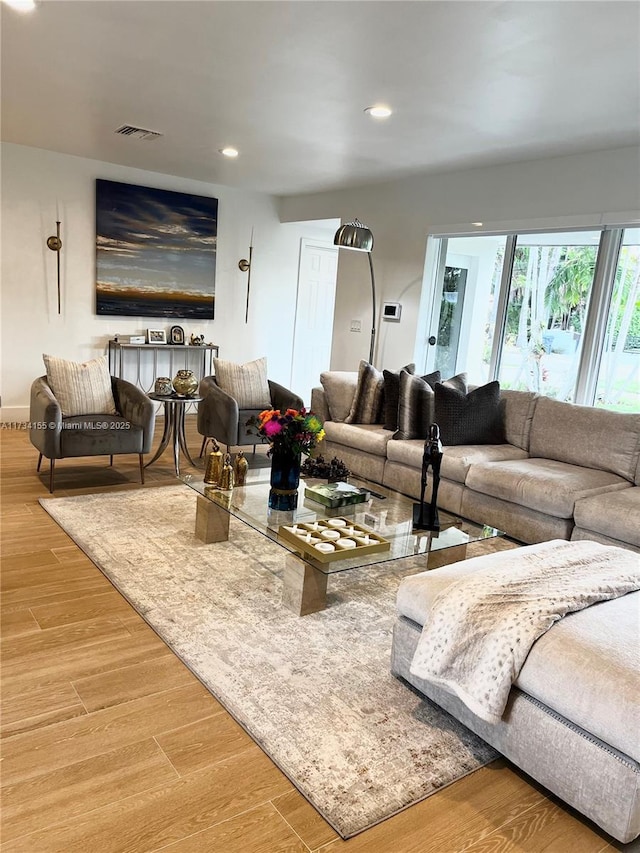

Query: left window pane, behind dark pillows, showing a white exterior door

[431,236,506,385]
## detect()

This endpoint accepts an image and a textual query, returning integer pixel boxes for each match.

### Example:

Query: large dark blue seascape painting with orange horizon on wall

[96,179,218,320]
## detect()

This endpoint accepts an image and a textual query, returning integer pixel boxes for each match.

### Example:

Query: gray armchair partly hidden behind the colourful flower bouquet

[198,376,304,456]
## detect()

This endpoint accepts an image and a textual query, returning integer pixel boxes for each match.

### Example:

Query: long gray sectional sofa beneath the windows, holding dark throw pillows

[311,371,640,551]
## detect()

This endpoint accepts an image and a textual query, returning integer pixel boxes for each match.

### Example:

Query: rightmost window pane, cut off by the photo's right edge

[596,228,640,412]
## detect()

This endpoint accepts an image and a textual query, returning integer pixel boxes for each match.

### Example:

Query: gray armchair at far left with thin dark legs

[29,376,155,492]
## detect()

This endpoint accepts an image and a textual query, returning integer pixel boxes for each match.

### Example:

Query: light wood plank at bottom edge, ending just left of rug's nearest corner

[144,803,309,853]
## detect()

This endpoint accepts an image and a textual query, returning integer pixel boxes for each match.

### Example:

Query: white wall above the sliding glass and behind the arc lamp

[280,148,640,370]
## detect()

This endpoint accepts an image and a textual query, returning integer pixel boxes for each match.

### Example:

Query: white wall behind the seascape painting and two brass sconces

[0,143,335,421]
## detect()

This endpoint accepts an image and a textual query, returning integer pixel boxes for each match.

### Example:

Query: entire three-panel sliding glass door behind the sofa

[416,223,640,411]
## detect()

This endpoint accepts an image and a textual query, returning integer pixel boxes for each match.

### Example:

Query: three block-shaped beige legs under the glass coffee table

[195,495,467,616]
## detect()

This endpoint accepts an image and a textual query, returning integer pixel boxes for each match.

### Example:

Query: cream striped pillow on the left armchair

[42,355,116,417]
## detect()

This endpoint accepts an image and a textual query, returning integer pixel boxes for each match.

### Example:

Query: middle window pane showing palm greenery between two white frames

[498,231,600,400]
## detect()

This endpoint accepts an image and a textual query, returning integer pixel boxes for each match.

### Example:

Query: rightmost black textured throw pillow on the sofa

[434,382,504,446]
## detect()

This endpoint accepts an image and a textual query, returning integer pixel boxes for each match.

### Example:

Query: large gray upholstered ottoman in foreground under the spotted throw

[391,542,640,843]
